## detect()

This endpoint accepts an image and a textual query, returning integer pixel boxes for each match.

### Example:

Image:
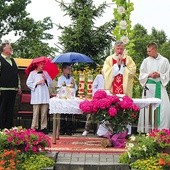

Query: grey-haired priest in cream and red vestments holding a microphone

[102,41,136,97]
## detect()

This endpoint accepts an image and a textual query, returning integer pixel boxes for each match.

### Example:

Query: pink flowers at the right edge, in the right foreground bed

[149,129,170,148]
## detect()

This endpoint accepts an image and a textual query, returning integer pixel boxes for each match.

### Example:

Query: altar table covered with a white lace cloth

[49,97,161,144]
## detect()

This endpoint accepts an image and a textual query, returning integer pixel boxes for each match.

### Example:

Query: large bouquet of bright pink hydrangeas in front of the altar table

[79,90,139,132]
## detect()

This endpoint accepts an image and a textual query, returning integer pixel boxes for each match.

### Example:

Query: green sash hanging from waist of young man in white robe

[146,79,161,126]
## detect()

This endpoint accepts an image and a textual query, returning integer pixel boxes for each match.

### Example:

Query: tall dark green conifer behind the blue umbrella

[57,0,115,64]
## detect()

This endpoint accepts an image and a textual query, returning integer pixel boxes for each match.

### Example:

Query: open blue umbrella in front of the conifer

[52,52,94,63]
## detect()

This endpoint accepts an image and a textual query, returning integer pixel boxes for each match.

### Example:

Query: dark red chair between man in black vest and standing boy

[17,93,33,126]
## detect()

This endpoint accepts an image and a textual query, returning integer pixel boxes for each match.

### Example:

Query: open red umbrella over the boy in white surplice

[25,56,59,79]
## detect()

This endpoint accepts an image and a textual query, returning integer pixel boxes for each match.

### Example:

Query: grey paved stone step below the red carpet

[54,152,129,170]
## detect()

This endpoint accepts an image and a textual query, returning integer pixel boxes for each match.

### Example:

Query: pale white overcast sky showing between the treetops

[4,0,170,46]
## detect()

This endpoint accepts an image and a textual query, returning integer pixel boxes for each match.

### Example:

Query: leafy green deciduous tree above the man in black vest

[0,0,57,58]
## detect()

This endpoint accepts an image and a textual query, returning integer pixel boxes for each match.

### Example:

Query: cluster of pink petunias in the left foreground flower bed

[3,127,51,153]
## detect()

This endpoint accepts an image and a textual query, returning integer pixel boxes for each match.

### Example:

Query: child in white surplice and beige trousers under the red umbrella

[26,61,52,133]
